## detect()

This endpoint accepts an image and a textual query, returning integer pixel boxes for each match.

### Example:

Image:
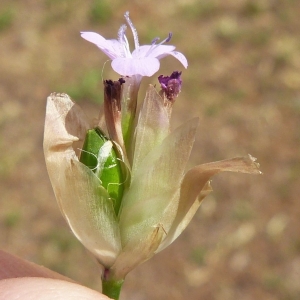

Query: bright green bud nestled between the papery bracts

[80,128,124,215]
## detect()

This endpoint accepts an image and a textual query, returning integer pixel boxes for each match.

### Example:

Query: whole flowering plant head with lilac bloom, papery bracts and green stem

[44,13,260,299]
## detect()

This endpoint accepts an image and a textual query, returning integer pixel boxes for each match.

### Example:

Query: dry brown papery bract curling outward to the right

[158,155,261,252]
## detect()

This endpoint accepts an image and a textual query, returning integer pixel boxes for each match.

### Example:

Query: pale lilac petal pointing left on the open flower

[81,32,125,59]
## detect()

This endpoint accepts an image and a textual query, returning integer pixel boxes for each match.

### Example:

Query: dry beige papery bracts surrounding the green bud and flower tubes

[44,86,260,280]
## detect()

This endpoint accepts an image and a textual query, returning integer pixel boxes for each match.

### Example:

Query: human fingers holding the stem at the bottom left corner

[0,250,109,300]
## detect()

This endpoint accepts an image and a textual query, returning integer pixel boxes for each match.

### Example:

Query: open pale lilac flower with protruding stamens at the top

[81,12,188,76]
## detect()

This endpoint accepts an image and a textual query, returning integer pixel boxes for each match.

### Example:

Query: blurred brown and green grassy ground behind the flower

[0,0,300,300]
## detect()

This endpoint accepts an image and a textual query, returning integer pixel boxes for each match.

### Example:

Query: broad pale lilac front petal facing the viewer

[111,57,160,76]
